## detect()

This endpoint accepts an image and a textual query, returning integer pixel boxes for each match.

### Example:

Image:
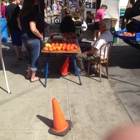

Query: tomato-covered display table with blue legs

[41,33,82,87]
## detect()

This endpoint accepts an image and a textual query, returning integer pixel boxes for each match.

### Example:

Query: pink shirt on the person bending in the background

[94,8,104,22]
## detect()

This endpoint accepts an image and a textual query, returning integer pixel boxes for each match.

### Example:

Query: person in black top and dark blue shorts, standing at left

[6,0,22,61]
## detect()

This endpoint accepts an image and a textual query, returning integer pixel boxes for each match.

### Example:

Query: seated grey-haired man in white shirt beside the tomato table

[76,18,113,76]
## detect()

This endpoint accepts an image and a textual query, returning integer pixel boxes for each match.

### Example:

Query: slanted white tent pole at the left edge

[0,42,11,94]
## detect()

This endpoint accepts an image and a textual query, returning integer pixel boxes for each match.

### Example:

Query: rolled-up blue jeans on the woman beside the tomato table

[21,38,43,71]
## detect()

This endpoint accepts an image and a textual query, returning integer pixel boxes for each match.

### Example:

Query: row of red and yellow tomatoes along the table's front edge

[42,42,78,52]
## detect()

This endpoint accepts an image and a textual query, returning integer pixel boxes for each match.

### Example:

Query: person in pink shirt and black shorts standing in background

[94,5,107,41]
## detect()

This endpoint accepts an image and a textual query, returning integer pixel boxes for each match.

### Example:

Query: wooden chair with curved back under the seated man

[88,42,113,82]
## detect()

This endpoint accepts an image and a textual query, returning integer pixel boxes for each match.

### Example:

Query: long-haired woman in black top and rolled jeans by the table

[18,0,44,82]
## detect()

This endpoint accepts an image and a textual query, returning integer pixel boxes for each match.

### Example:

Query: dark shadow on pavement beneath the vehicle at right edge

[109,45,140,69]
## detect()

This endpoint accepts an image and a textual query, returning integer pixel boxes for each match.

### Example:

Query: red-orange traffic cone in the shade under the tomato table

[60,56,70,75]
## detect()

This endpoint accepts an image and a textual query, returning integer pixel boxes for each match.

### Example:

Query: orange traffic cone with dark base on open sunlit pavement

[49,98,72,136]
